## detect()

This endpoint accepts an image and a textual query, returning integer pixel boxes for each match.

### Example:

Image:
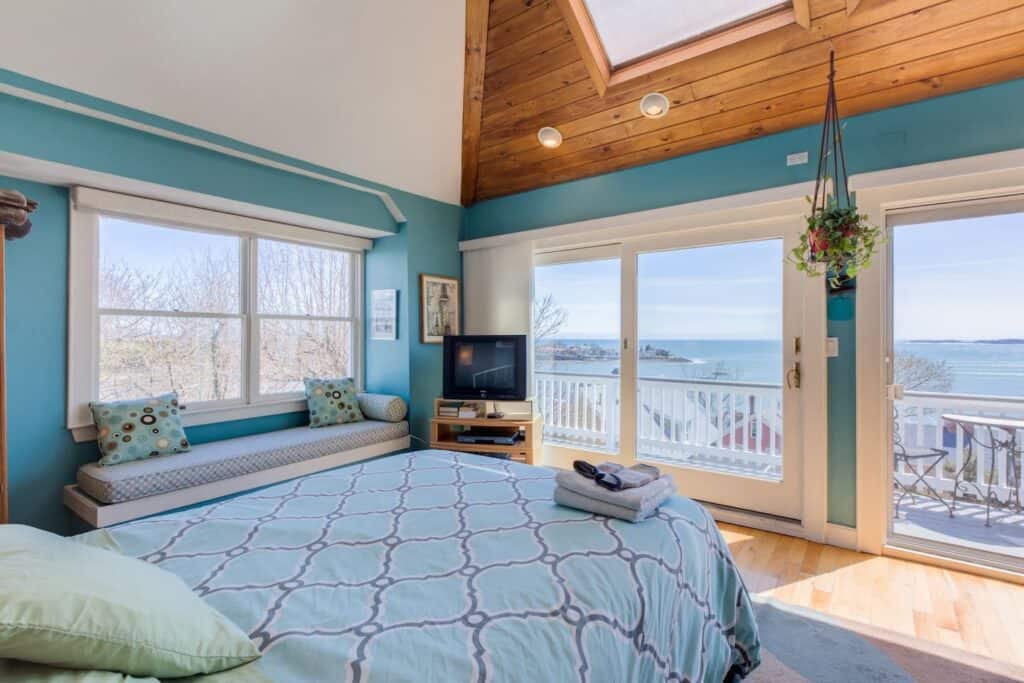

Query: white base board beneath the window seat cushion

[63,436,410,528]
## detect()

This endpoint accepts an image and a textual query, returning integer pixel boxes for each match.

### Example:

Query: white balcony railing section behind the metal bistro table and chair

[894,391,1024,501]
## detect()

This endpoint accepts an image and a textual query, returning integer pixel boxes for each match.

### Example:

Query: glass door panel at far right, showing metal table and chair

[890,205,1024,566]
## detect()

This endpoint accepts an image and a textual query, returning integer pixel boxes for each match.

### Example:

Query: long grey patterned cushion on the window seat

[78,420,409,504]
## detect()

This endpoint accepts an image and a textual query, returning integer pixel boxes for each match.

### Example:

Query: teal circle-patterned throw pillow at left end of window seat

[89,392,190,465]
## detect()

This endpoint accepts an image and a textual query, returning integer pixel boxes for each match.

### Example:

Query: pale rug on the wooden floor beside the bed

[745,597,1024,683]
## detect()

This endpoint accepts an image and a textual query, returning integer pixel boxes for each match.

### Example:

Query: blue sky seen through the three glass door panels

[535,213,1024,340]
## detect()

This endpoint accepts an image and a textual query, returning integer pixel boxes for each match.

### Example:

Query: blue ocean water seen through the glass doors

[535,339,1024,396]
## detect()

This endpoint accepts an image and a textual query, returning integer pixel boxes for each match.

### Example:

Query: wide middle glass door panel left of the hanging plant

[635,238,801,518]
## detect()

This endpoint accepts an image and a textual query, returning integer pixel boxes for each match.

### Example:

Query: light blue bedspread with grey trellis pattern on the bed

[94,451,759,683]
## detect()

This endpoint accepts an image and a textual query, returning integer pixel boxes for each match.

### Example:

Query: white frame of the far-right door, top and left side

[850,150,1024,554]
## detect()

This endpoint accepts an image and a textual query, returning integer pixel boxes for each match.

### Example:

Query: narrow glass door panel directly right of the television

[534,254,622,454]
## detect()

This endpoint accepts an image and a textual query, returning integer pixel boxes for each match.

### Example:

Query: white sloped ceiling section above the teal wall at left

[0,0,465,204]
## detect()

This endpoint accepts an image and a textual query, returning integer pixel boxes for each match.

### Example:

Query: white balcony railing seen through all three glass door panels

[535,372,1024,500]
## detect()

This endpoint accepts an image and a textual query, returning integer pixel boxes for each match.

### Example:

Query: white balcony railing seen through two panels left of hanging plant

[535,373,782,478]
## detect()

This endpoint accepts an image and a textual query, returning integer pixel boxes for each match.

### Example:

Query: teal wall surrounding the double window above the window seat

[0,71,463,532]
